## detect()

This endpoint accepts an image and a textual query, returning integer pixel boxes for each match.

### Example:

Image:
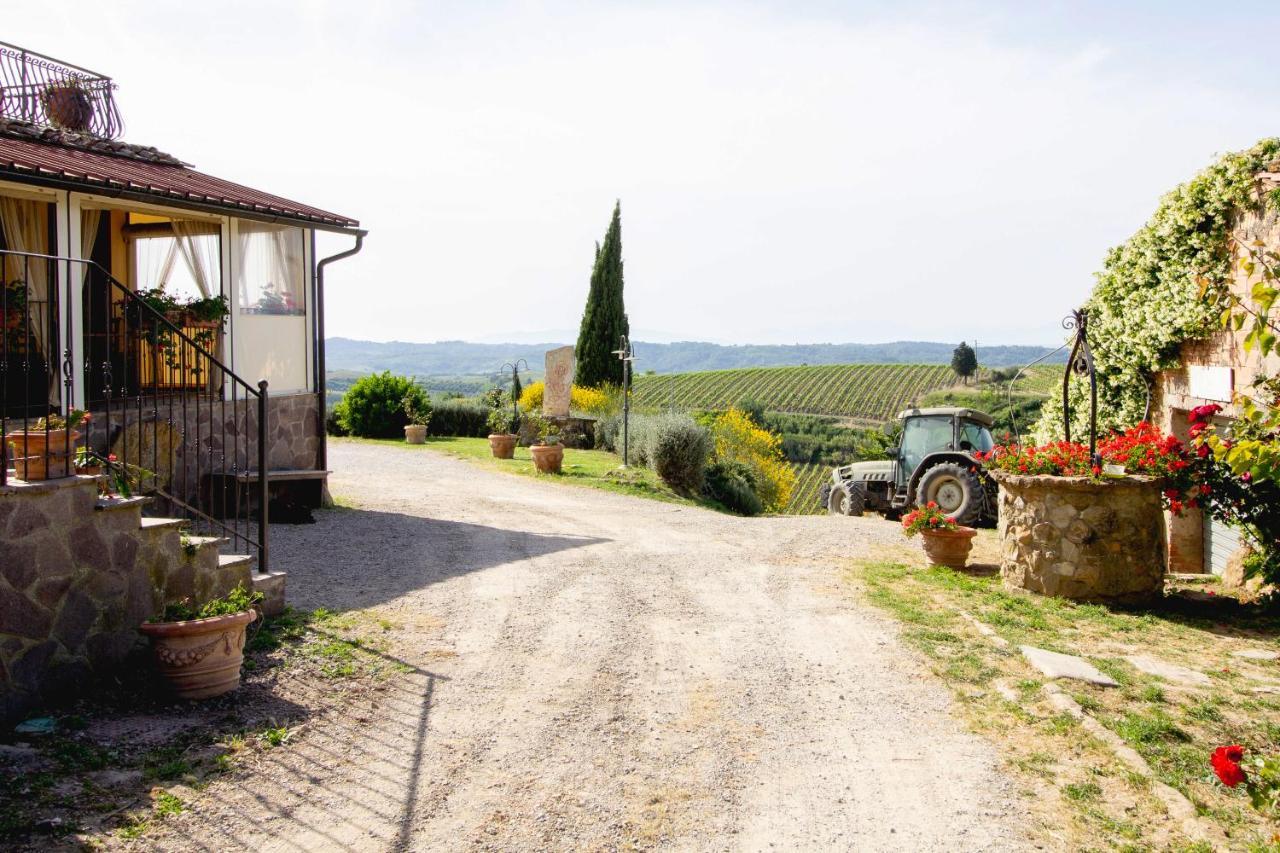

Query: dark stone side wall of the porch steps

[0,476,250,720]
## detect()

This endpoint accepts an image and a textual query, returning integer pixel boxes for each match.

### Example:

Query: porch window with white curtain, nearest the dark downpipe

[237,219,306,315]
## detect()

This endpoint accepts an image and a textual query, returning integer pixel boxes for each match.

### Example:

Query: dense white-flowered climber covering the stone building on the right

[1036,137,1280,442]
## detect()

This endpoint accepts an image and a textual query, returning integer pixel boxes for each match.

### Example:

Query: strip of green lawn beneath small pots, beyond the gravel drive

[329,435,724,512]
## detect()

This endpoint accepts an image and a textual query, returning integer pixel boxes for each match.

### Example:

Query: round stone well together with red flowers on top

[979,423,1194,603]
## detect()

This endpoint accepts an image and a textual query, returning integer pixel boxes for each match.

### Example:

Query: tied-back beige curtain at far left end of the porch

[0,196,61,407]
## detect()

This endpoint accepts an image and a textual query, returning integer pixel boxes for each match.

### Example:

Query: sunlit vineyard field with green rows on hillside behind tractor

[635,364,955,424]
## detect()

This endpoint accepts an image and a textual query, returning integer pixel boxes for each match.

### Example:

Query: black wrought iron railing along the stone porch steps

[0,250,269,571]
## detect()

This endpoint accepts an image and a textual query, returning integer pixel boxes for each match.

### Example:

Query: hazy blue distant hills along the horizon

[325,338,1066,377]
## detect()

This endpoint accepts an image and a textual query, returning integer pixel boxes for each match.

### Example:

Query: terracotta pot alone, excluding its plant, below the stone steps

[140,610,257,699]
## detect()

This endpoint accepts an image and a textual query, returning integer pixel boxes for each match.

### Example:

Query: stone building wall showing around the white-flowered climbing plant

[1151,172,1280,580]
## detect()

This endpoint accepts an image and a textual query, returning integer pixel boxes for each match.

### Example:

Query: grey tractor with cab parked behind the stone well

[820,406,996,526]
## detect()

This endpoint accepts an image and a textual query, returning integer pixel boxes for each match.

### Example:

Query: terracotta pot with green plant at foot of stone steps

[138,584,262,699]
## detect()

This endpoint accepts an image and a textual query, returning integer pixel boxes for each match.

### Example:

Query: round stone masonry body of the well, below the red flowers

[992,471,1169,603]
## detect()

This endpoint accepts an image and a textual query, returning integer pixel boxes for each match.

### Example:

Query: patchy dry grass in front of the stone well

[849,534,1280,850]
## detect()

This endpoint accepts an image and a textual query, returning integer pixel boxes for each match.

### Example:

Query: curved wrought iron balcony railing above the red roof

[0,41,123,140]
